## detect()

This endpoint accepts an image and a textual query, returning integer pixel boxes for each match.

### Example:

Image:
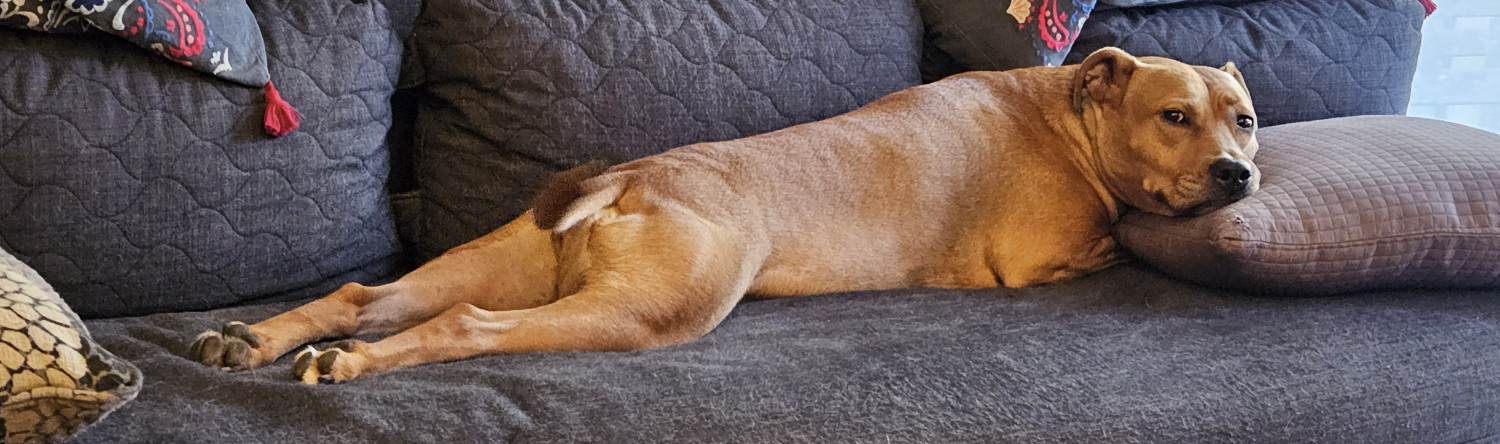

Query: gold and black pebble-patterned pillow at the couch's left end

[0,251,141,443]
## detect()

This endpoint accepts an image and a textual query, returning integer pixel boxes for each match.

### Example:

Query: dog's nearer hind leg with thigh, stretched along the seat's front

[294,210,759,384]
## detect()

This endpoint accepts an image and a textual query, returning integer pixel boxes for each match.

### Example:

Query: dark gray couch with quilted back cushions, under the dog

[0,0,1500,443]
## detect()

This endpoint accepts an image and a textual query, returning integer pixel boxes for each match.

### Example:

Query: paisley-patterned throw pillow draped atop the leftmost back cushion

[0,0,270,87]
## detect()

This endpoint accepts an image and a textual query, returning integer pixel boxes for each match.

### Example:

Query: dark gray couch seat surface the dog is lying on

[64,266,1500,443]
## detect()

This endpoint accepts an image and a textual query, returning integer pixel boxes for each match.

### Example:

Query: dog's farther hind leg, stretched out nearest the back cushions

[188,213,557,369]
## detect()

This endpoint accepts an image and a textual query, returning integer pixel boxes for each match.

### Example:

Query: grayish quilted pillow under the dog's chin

[1116,116,1500,294]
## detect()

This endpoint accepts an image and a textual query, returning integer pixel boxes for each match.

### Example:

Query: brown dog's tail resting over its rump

[531,161,626,233]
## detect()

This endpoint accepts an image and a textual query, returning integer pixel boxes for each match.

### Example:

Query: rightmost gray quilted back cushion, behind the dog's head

[1068,0,1425,126]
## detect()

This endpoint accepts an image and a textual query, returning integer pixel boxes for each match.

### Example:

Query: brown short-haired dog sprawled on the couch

[191,48,1259,384]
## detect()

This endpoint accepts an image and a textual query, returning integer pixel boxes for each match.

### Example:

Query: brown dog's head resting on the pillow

[1073,48,1260,216]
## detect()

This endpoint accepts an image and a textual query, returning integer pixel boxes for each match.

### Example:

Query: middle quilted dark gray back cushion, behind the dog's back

[414,0,921,255]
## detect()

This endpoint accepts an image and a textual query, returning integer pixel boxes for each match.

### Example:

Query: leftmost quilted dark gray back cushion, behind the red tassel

[0,0,401,317]
